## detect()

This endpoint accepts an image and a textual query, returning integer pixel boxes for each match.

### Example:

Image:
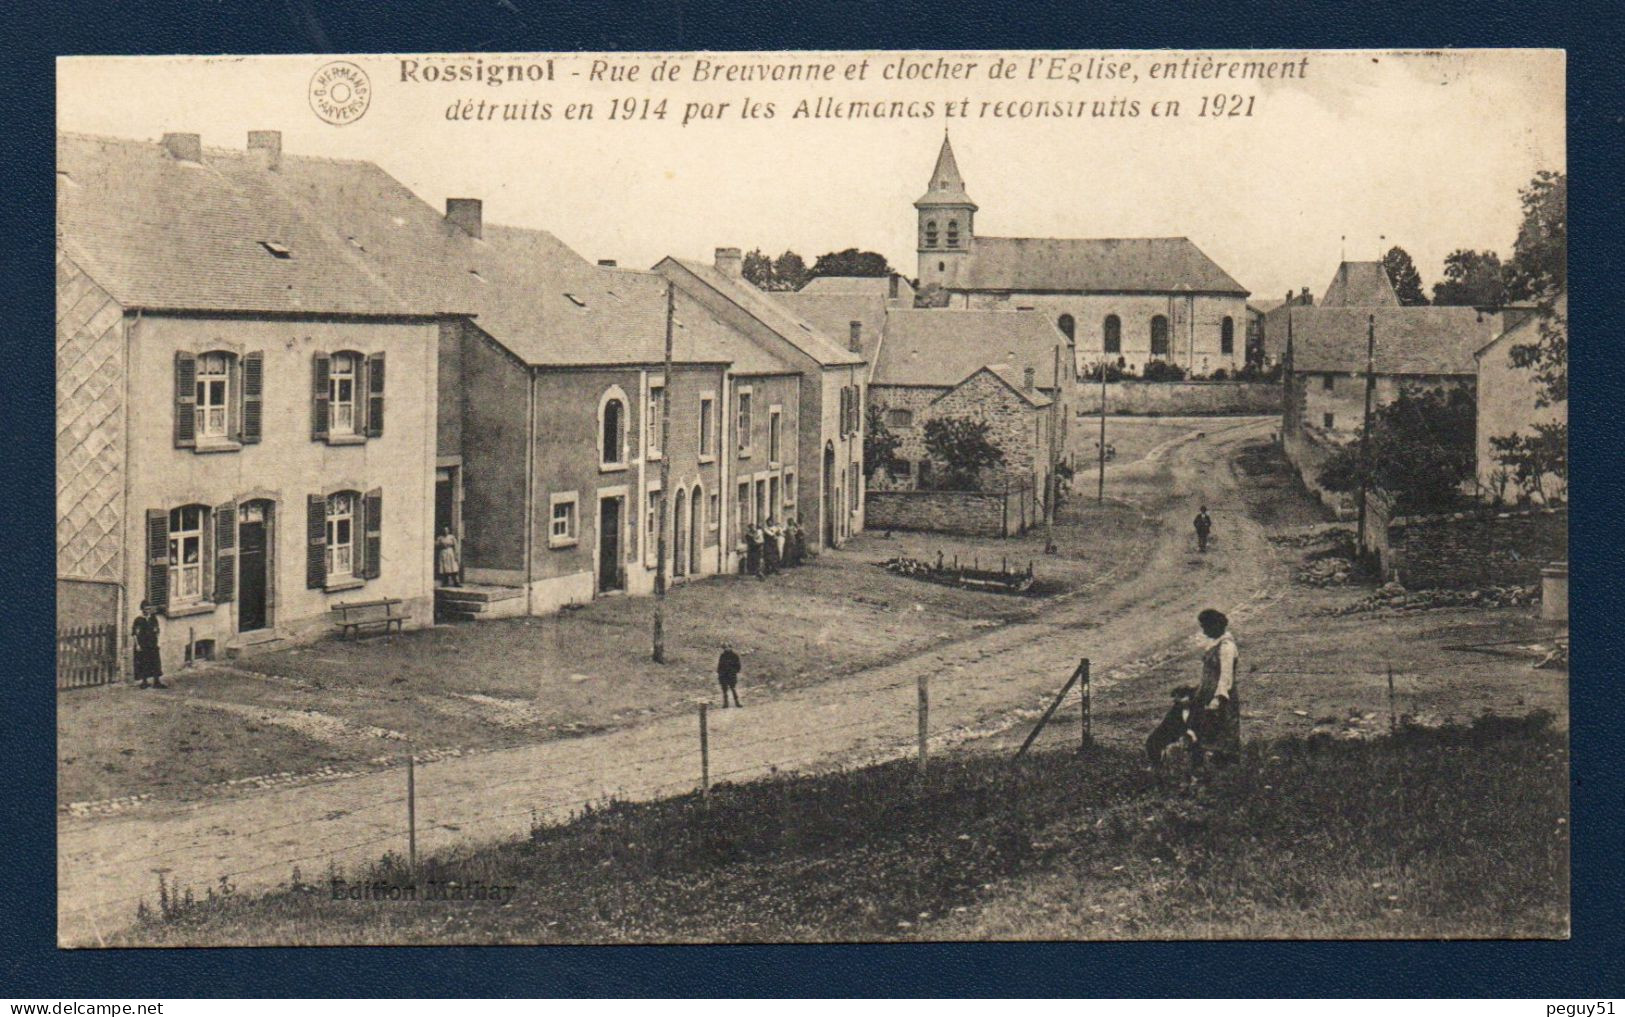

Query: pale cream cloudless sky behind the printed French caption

[57,50,1565,299]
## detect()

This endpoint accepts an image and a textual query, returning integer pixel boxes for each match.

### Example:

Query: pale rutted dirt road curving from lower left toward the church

[57,418,1285,946]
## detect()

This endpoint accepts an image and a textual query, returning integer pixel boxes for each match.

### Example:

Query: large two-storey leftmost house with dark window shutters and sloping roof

[57,132,448,666]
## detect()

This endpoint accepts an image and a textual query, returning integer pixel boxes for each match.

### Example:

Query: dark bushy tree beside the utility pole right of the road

[1320,387,1477,512]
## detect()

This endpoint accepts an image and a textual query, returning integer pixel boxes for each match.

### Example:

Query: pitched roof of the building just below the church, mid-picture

[869,307,1068,388]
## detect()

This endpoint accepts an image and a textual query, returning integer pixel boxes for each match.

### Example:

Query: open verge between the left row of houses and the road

[57,502,1155,803]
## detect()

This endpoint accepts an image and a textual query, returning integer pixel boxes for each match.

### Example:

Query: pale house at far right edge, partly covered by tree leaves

[1474,292,1568,497]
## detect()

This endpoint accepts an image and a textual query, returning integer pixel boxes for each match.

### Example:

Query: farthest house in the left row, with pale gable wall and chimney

[655,247,866,552]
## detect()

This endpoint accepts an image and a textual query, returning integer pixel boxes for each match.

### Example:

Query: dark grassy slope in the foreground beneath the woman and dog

[120,715,1568,946]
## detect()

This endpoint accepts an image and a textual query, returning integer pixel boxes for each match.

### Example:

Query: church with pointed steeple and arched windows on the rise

[915,135,1248,377]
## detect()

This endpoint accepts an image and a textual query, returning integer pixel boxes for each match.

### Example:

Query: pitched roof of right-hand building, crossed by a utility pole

[1281,307,1500,374]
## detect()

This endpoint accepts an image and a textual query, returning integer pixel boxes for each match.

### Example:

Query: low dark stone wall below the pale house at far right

[1383,507,1568,590]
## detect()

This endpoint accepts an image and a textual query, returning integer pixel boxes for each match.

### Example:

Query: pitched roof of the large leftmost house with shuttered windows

[57,133,438,315]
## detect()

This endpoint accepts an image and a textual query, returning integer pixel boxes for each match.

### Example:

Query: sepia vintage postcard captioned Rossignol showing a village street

[55,50,1570,949]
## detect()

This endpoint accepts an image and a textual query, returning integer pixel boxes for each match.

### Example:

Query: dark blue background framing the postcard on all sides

[0,0,1625,998]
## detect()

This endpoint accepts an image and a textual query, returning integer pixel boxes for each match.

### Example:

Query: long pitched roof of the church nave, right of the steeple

[954,236,1246,296]
